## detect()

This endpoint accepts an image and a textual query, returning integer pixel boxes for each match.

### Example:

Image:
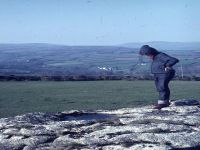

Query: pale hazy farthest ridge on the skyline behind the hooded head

[121,41,200,50]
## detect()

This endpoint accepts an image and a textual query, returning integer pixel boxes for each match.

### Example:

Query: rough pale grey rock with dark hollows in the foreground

[0,100,200,150]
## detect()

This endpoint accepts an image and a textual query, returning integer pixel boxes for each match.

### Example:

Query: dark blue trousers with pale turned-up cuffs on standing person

[154,70,175,104]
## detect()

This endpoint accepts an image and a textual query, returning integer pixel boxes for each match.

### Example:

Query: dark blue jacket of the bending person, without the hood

[151,52,179,74]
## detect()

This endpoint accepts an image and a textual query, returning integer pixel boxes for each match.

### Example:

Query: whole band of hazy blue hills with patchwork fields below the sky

[0,42,200,76]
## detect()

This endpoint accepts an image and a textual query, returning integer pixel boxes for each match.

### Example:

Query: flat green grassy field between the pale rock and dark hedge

[0,81,200,117]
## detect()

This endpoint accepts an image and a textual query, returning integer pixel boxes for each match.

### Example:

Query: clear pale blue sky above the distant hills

[0,0,200,45]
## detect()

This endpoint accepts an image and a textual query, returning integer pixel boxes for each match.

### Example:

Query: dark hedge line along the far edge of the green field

[0,75,200,81]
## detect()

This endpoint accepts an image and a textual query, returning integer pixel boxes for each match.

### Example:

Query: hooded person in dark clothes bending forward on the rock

[139,45,179,109]
